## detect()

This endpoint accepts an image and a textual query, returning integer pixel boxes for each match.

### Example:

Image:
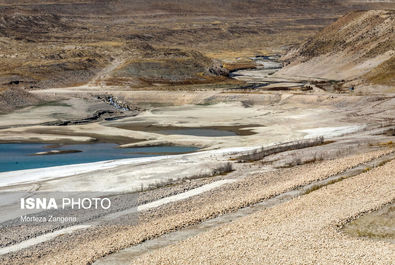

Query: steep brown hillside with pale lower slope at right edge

[278,10,395,85]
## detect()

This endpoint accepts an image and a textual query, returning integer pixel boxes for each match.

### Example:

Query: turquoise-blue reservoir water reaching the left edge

[0,143,198,172]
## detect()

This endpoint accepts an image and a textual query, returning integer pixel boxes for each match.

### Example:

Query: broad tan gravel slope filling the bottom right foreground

[131,158,395,264]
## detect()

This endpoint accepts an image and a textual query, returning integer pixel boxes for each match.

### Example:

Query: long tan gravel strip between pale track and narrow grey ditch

[4,150,391,264]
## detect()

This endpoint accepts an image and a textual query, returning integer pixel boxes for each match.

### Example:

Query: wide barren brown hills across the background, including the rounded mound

[0,0,395,89]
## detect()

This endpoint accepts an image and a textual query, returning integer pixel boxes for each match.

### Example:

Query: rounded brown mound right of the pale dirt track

[107,48,227,85]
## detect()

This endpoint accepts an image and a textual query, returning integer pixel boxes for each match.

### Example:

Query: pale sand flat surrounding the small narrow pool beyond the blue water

[102,99,356,149]
